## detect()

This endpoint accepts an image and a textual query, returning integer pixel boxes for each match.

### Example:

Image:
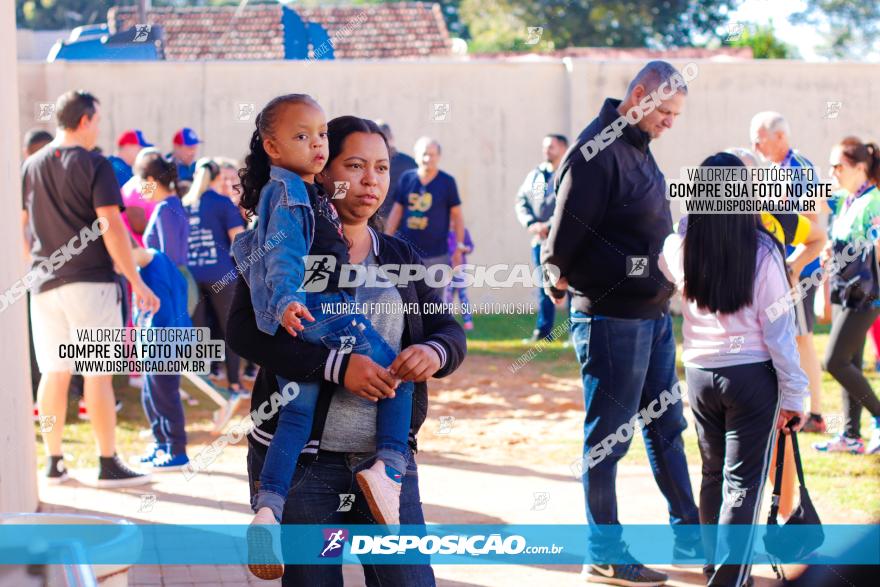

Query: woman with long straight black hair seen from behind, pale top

[660,153,809,587]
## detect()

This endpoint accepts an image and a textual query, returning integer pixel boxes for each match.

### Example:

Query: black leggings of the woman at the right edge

[825,304,880,438]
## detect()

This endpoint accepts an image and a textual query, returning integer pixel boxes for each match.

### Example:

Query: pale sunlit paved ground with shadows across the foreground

[40,446,784,587]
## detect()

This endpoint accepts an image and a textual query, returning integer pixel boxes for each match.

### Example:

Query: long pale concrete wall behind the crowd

[13,59,880,301]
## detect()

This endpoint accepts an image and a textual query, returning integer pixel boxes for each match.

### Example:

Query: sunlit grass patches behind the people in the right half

[468,314,880,521]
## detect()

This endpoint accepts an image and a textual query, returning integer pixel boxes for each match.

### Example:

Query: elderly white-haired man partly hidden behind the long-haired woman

[749,111,826,433]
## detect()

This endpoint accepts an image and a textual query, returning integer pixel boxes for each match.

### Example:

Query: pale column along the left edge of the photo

[0,2,39,512]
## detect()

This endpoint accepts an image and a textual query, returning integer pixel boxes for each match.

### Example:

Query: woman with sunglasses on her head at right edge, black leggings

[813,137,880,454]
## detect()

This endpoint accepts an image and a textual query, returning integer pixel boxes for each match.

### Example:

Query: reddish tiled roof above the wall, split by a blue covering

[107,2,451,61]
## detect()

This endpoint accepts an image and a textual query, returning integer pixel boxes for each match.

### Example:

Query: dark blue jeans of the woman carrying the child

[247,437,435,587]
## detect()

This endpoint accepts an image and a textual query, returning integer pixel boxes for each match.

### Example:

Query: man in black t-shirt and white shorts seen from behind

[21,91,159,487]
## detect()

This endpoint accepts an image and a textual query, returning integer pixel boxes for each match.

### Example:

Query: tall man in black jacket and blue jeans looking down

[541,61,699,585]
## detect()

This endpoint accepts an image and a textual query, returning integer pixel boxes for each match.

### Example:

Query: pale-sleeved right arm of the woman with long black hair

[754,250,810,420]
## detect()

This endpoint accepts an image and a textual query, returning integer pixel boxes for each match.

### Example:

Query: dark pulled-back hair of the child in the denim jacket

[238,94,320,218]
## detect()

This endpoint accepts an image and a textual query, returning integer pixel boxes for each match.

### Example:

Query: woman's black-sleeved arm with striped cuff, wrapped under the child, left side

[226,276,393,400]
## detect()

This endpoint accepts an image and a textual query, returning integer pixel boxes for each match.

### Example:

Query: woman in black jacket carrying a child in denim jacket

[227,94,466,586]
